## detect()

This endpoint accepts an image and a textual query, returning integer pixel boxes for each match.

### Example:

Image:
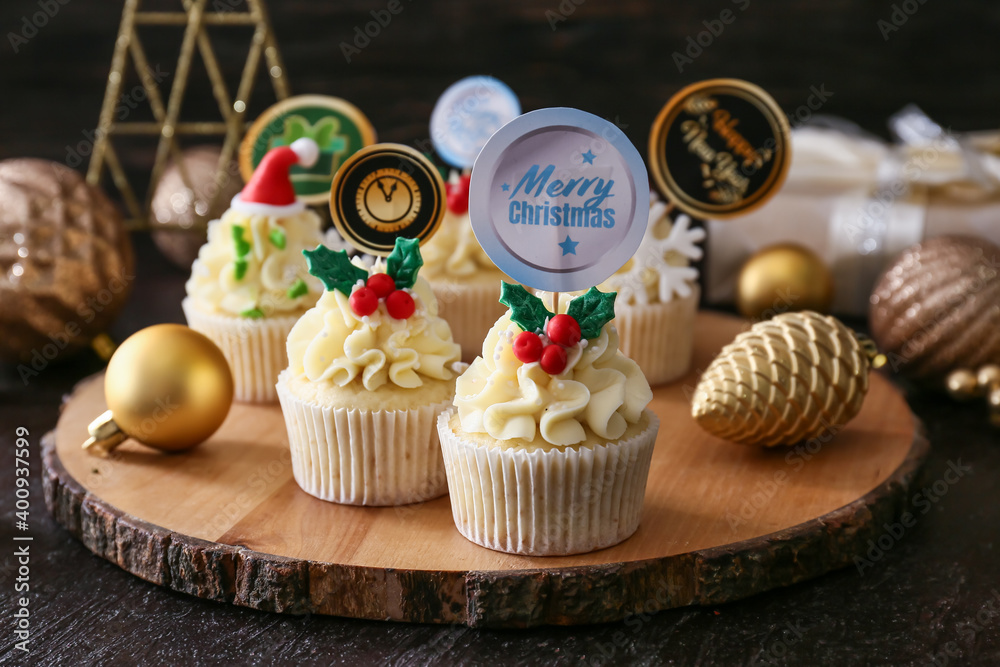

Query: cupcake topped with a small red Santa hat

[182,139,323,403]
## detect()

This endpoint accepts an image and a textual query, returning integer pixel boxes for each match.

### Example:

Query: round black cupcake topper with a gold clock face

[330,144,445,256]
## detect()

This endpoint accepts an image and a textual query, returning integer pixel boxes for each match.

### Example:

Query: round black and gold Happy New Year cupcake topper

[649,79,789,219]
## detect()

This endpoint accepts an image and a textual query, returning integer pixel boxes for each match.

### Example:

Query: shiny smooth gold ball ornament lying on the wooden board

[83,324,233,456]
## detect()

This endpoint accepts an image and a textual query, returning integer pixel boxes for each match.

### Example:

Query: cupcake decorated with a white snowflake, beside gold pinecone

[599,195,705,385]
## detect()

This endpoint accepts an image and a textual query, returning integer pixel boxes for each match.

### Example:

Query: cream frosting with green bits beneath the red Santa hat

[185,209,323,317]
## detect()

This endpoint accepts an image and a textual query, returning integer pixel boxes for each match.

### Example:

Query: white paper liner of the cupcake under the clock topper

[277,372,451,505]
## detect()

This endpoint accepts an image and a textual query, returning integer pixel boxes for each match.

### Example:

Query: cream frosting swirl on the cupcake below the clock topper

[288,260,461,391]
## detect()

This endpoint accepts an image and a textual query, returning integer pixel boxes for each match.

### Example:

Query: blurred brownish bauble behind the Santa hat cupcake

[149,146,243,269]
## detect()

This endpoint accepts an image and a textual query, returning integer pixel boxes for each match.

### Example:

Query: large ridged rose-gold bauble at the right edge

[869,236,1000,383]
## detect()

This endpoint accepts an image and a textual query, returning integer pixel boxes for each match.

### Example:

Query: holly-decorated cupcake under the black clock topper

[277,239,461,505]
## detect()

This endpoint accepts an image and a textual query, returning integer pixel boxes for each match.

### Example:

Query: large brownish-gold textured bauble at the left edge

[0,158,135,362]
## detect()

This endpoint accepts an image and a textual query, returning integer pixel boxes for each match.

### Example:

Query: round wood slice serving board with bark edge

[44,313,928,627]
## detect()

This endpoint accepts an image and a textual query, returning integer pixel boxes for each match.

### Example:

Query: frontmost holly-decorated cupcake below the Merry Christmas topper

[438,284,659,556]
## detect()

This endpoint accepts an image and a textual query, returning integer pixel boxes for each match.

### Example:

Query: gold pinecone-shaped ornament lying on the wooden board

[691,312,873,447]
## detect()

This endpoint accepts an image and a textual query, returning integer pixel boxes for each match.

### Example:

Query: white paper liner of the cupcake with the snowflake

[614,285,700,386]
